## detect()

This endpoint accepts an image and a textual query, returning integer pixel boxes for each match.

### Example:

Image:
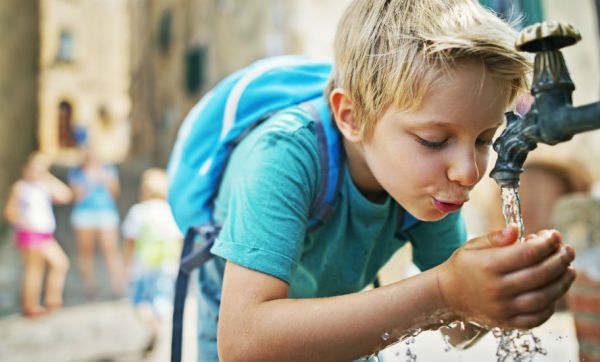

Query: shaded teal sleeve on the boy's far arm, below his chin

[406,212,467,271]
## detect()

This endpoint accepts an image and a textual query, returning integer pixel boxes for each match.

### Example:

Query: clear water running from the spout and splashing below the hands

[492,187,547,362]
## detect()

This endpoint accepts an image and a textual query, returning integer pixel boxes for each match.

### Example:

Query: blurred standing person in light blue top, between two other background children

[69,149,125,296]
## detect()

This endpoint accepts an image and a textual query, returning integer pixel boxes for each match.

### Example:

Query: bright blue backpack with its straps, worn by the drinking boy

[168,56,417,361]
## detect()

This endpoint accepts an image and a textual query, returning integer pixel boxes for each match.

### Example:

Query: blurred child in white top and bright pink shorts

[4,152,73,317]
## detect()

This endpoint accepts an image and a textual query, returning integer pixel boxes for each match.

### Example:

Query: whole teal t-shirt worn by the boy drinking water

[211,108,466,298]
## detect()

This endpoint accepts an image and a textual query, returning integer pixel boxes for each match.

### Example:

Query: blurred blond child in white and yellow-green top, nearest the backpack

[122,168,182,349]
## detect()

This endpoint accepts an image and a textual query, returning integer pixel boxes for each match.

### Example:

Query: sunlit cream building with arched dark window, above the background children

[38,0,130,164]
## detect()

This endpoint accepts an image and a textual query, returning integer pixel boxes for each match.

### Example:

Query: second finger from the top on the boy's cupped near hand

[503,245,575,295]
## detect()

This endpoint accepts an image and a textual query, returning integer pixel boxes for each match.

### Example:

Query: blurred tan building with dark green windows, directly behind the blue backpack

[129,0,349,165]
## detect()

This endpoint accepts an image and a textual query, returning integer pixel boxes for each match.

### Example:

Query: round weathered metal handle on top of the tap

[515,21,581,53]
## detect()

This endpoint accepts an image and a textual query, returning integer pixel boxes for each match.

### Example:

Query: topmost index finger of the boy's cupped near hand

[494,230,562,273]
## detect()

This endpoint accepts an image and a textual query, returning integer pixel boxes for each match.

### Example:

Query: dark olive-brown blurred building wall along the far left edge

[0,0,39,230]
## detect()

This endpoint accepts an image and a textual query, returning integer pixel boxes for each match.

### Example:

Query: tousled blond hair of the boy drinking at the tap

[326,0,531,139]
